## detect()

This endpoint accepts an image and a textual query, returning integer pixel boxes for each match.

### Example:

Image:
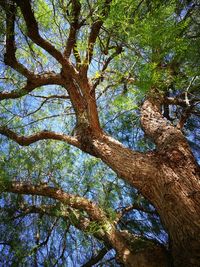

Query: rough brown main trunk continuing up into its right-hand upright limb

[142,98,200,267]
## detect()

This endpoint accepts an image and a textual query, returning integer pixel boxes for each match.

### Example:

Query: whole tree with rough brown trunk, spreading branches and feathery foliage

[0,0,200,266]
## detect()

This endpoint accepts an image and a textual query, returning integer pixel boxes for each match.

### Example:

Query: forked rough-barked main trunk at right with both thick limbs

[79,96,200,267]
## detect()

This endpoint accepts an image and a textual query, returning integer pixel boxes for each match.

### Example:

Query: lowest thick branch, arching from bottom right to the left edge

[1,181,166,267]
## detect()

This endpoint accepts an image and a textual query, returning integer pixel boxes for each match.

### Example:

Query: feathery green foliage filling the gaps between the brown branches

[0,0,200,266]
